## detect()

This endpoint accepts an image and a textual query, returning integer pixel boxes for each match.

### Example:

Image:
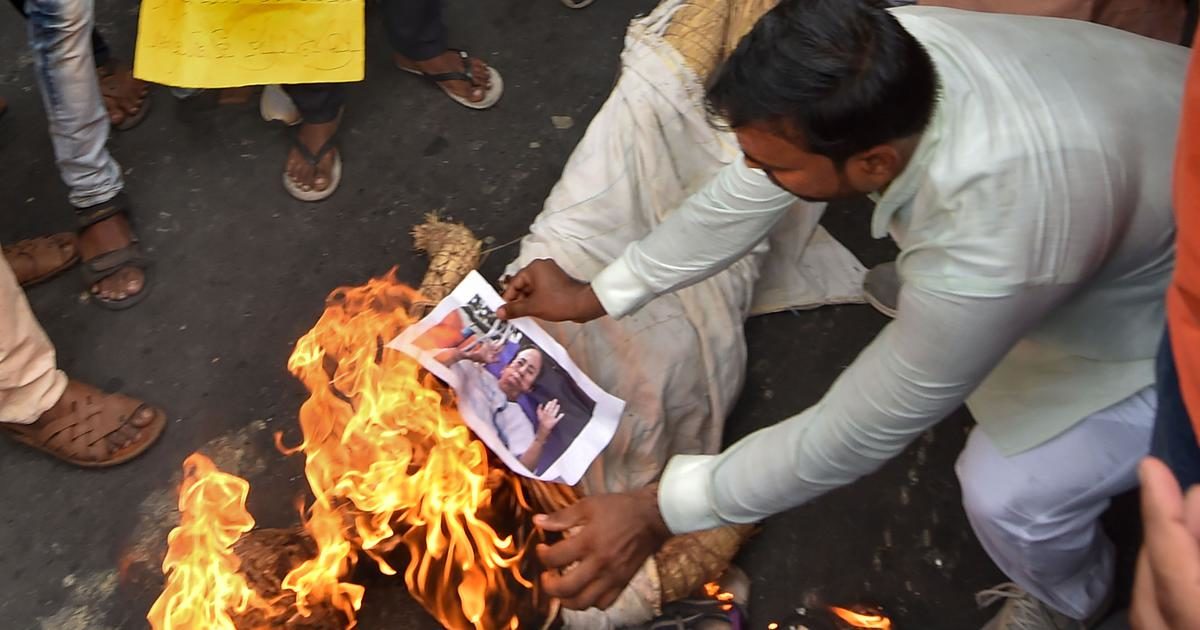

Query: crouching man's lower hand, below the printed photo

[533,486,671,610]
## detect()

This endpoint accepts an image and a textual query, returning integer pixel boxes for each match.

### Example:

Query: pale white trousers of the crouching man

[956,386,1158,619]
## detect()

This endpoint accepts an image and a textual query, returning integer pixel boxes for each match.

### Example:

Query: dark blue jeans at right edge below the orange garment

[1150,330,1200,490]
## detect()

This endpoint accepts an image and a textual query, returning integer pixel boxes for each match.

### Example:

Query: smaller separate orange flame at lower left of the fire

[148,454,270,630]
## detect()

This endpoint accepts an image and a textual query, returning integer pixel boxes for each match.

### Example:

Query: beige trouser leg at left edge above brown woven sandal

[0,256,67,425]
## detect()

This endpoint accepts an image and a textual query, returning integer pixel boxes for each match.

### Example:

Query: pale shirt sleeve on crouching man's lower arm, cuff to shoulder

[659,283,1072,533]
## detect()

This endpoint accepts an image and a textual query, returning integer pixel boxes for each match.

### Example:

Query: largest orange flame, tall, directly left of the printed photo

[284,275,532,630]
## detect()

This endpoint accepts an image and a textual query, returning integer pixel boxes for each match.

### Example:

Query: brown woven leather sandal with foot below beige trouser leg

[0,380,167,468]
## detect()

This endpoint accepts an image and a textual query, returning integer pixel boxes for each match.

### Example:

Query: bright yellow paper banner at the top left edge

[133,0,364,88]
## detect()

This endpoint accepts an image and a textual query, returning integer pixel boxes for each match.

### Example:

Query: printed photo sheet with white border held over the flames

[388,271,625,485]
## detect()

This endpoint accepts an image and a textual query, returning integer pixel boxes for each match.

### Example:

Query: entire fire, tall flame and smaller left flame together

[150,275,532,630]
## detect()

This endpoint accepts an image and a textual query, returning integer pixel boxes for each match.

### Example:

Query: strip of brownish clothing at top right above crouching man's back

[917,0,1187,43]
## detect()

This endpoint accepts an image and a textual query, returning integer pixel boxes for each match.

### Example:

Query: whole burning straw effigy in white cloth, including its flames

[150,0,883,630]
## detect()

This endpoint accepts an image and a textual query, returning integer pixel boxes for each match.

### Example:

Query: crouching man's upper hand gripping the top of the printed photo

[496,259,605,323]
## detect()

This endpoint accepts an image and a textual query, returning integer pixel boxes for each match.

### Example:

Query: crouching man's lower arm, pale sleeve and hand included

[535,277,1070,608]
